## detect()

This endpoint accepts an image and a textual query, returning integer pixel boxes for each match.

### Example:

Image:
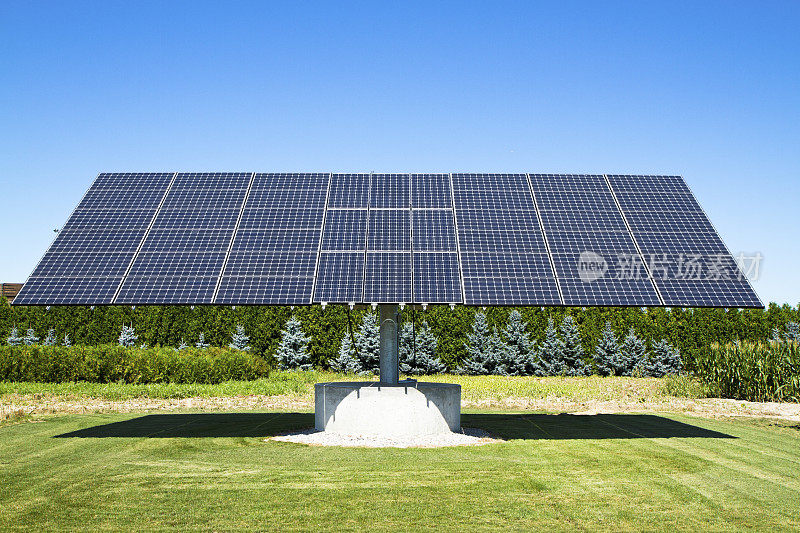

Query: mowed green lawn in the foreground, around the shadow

[0,412,800,531]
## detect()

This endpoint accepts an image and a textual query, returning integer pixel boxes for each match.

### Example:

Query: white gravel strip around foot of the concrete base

[265,428,502,448]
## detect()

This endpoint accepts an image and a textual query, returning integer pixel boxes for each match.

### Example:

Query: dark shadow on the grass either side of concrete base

[57,413,734,439]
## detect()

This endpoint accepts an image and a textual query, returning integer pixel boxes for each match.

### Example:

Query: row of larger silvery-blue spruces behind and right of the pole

[276,311,682,377]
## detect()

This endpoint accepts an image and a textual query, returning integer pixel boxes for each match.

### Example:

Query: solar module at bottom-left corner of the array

[14,277,122,305]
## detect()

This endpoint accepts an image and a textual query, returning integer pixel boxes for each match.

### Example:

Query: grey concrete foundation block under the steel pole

[314,381,461,437]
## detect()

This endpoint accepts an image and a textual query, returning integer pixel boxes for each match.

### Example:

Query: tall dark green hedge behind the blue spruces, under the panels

[0,298,800,371]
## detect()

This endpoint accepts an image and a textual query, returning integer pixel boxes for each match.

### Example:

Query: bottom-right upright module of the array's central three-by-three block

[414,252,462,303]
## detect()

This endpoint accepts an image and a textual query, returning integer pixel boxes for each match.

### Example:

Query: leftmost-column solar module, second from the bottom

[31,252,133,278]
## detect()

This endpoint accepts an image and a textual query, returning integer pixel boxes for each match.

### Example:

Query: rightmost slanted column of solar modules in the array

[608,175,761,307]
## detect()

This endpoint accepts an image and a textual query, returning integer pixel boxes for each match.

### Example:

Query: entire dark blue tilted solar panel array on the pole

[14,173,762,307]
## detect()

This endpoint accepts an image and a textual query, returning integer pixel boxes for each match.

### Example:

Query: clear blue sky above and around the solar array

[0,1,800,304]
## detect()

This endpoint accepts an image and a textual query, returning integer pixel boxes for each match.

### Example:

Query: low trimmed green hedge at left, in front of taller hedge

[0,344,269,383]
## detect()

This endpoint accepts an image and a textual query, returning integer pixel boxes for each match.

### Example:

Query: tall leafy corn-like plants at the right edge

[695,341,800,402]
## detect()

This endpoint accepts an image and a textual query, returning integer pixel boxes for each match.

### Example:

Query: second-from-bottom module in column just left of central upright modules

[224,251,318,278]
